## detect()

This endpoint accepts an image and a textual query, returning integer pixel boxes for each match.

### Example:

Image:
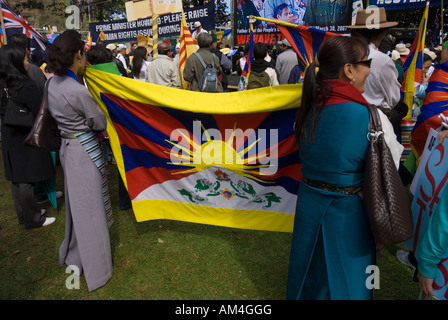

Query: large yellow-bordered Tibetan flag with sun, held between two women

[85,66,302,232]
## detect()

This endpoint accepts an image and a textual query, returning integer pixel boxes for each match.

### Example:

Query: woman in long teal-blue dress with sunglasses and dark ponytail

[287,36,376,300]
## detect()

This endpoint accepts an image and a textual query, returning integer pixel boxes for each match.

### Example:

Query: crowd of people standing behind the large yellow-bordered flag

[79,25,303,92]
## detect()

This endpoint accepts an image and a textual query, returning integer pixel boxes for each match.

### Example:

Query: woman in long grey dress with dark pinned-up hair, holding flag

[48,31,113,291]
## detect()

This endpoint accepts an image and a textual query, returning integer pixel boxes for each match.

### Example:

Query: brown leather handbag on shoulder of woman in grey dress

[24,79,61,151]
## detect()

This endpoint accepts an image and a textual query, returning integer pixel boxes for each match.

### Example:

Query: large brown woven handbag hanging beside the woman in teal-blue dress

[363,106,414,246]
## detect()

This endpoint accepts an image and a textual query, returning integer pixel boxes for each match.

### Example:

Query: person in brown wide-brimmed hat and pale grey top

[347,7,406,122]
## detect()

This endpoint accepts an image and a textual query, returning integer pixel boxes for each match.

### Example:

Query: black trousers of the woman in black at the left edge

[11,183,45,229]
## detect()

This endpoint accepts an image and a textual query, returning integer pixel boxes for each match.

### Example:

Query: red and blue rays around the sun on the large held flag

[101,93,301,199]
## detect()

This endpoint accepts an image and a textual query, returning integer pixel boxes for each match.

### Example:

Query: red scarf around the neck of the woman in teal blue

[325,79,369,106]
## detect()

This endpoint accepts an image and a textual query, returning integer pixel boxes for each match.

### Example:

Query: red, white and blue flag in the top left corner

[0,0,46,56]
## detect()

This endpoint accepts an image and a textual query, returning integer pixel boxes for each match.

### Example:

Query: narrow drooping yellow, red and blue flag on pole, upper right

[401,1,429,120]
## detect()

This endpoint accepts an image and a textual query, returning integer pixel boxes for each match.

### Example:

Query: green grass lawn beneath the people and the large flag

[0,149,419,300]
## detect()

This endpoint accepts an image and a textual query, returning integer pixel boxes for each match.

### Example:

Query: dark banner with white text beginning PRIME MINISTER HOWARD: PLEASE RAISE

[89,3,215,43]
